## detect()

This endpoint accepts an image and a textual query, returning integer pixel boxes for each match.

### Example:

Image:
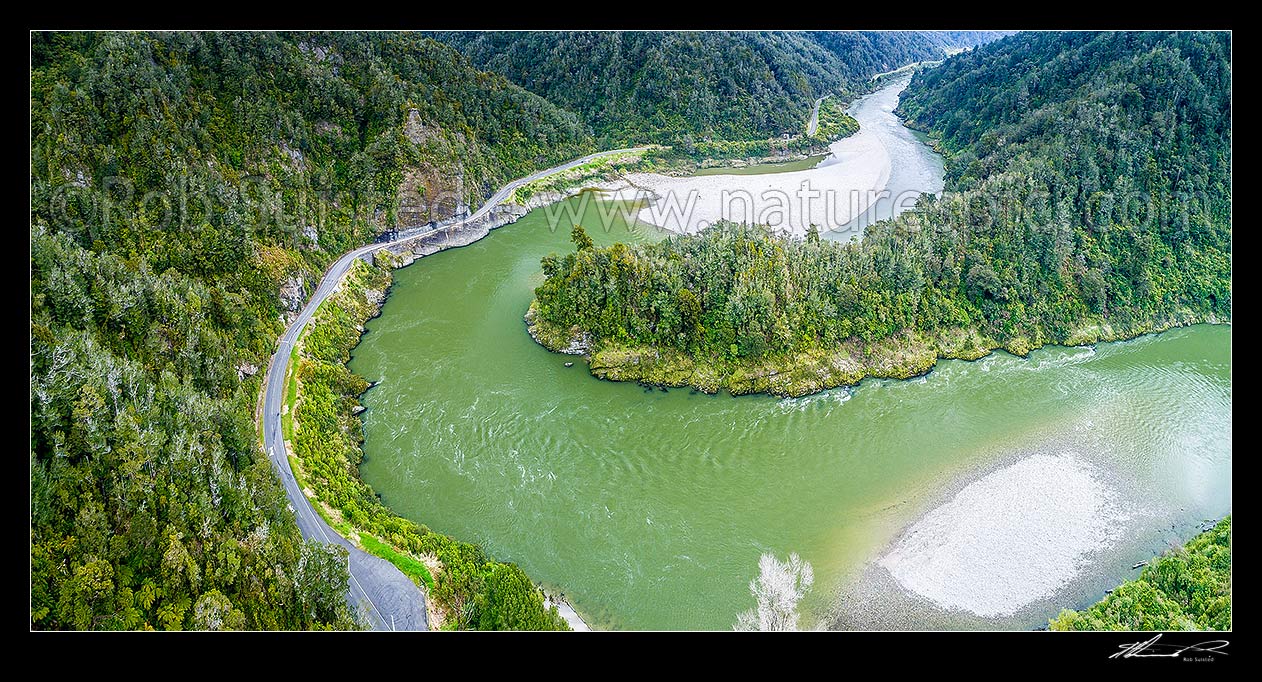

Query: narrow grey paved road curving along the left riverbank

[262,148,642,630]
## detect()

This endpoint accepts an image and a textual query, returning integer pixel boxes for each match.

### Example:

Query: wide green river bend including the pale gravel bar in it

[351,73,1232,629]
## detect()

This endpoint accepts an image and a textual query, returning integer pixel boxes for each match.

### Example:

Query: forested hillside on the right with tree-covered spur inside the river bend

[531,33,1232,394]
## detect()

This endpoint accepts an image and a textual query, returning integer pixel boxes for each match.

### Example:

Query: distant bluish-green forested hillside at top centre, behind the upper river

[433,32,997,147]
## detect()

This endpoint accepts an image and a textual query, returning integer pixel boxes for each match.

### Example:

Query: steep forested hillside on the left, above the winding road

[30,33,592,629]
